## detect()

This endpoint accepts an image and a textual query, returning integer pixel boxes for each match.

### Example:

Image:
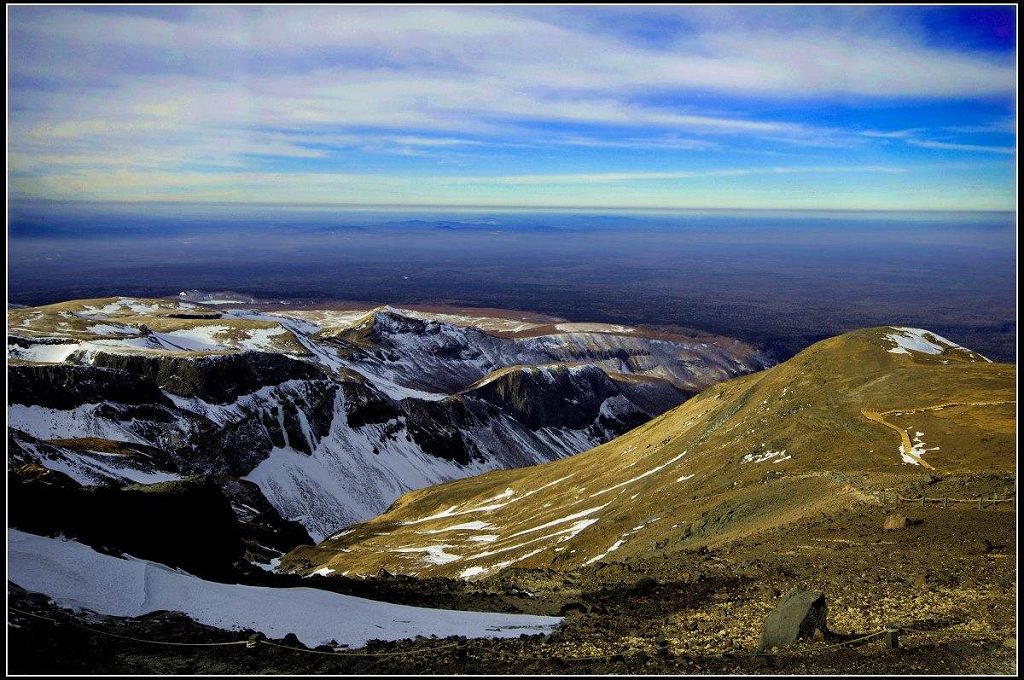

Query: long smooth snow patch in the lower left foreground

[7,528,561,647]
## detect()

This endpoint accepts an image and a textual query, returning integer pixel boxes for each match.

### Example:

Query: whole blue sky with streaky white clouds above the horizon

[7,5,1017,210]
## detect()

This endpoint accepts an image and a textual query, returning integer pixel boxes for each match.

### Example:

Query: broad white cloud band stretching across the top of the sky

[12,6,1015,97]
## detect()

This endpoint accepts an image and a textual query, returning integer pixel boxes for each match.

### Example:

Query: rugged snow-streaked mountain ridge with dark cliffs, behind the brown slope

[8,298,769,548]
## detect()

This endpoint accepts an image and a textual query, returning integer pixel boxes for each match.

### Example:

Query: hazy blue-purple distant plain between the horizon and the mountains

[8,201,1016,360]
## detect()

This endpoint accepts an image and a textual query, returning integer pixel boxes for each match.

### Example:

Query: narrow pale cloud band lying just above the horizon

[11,166,1013,210]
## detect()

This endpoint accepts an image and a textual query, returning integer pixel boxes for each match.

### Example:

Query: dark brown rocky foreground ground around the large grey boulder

[9,499,1017,675]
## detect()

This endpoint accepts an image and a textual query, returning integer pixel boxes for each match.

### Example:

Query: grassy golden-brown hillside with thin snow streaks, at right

[282,328,1016,576]
